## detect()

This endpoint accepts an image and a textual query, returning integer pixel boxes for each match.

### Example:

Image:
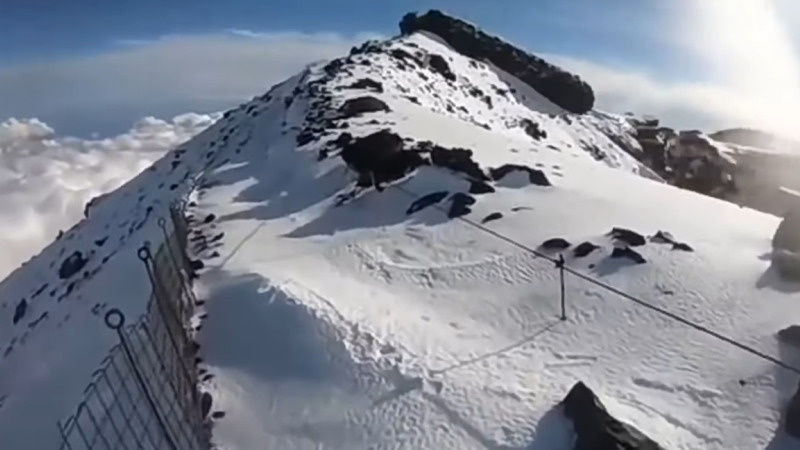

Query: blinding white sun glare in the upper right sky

[678,0,800,138]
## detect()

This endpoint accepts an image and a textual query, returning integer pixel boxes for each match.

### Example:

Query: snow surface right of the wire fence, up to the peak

[186,35,800,450]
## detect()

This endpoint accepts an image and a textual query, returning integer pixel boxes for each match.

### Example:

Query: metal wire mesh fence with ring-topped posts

[58,205,211,450]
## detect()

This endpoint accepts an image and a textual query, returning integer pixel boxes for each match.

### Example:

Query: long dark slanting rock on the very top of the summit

[400,10,594,114]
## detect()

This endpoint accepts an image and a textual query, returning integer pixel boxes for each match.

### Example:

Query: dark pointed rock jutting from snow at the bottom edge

[561,382,664,450]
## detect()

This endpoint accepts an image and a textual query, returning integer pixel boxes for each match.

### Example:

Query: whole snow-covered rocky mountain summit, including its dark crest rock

[0,7,800,450]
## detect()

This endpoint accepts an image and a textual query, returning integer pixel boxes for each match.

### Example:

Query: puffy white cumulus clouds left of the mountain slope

[0,114,216,278]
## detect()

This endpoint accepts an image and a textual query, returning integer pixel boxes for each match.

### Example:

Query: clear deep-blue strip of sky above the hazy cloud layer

[0,0,668,65]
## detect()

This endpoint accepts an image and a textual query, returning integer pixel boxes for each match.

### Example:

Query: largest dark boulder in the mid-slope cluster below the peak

[341,129,425,189]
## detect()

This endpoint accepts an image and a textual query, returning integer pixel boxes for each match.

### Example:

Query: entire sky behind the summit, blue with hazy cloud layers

[0,0,800,136]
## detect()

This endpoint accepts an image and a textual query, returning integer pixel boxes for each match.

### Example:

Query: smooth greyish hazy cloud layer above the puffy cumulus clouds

[0,30,374,136]
